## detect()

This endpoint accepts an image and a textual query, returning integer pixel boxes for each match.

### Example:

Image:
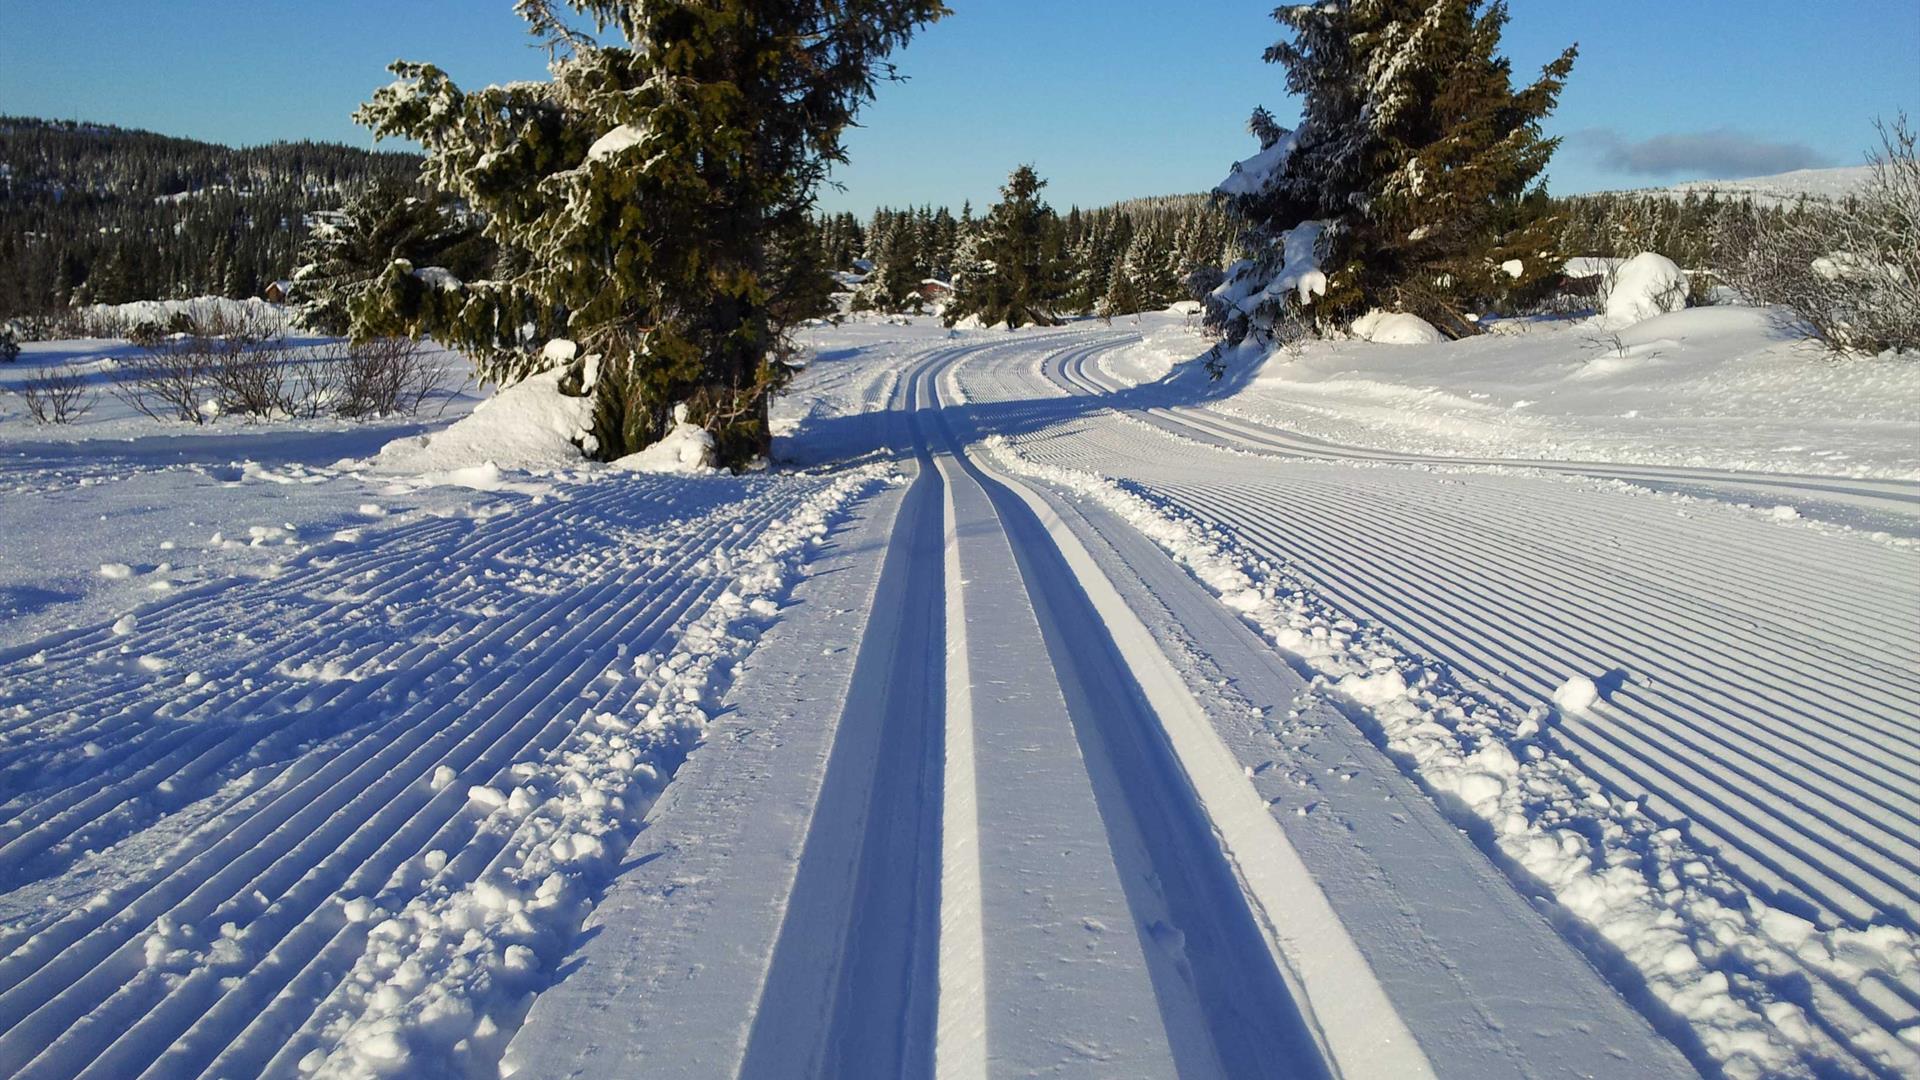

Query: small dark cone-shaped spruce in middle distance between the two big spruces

[947,165,1069,331]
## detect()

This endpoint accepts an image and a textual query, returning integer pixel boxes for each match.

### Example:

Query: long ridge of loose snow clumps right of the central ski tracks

[985,436,1920,1080]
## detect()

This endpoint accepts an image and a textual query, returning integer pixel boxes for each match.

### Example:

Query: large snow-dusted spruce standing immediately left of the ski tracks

[357,0,947,457]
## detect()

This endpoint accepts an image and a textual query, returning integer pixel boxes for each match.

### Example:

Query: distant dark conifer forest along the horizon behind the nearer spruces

[0,117,1827,319]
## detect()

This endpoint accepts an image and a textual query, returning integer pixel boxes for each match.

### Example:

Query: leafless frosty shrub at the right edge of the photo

[1720,115,1920,354]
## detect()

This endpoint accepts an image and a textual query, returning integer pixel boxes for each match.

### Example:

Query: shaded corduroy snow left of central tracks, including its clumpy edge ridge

[0,469,881,1078]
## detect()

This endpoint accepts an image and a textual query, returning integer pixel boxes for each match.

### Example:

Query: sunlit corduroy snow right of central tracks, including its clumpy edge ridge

[958,334,1920,1076]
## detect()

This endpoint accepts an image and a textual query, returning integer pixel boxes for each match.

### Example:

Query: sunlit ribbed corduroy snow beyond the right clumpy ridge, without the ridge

[944,338,1920,1072]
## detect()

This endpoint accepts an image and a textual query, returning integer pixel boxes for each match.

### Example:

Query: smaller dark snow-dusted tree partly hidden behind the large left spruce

[294,181,495,334]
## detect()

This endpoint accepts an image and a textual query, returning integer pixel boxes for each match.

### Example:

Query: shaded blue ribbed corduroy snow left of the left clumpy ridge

[0,465,871,1078]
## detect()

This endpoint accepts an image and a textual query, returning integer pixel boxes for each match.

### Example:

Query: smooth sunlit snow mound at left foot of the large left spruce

[367,371,593,474]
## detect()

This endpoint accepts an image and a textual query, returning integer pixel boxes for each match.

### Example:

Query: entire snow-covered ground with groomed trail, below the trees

[0,307,1920,1078]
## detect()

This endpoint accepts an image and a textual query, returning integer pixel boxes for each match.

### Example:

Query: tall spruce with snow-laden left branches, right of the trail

[1208,0,1576,342]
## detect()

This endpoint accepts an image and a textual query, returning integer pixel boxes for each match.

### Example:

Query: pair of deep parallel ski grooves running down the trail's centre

[729,334,1397,1076]
